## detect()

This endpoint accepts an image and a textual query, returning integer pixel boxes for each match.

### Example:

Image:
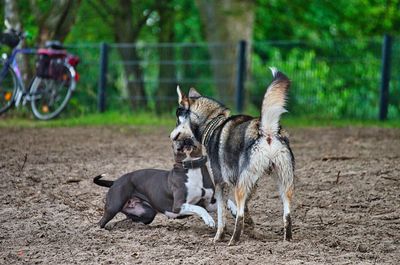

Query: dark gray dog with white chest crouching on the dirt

[93,139,222,228]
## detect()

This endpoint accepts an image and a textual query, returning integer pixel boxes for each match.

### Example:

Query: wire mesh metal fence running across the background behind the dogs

[64,38,400,119]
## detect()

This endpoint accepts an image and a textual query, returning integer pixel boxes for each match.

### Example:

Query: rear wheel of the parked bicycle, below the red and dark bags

[30,63,76,120]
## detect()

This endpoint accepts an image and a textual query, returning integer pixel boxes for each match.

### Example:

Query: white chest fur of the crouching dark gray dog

[185,168,212,204]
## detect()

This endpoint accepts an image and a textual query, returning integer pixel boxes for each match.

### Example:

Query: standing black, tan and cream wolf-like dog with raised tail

[170,68,294,245]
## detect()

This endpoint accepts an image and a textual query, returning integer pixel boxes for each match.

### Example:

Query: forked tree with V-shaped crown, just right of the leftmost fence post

[89,0,156,109]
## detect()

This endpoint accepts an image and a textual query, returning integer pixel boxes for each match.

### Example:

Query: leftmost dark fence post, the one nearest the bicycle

[97,42,108,112]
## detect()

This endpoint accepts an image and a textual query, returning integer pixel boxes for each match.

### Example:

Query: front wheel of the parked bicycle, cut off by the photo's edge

[0,61,18,114]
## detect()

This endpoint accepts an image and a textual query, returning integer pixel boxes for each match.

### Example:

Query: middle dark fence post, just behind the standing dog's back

[236,40,247,113]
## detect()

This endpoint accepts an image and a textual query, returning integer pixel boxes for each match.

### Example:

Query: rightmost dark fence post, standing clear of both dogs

[379,34,392,121]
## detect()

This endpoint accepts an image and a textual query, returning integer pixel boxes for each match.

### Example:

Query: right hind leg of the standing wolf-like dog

[274,153,294,241]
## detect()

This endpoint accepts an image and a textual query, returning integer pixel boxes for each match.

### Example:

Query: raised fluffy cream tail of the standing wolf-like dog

[260,67,290,135]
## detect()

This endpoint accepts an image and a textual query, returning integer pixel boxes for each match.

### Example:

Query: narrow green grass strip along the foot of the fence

[0,112,400,128]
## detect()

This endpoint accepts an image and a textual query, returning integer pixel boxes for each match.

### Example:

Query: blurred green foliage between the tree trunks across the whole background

[0,0,400,119]
